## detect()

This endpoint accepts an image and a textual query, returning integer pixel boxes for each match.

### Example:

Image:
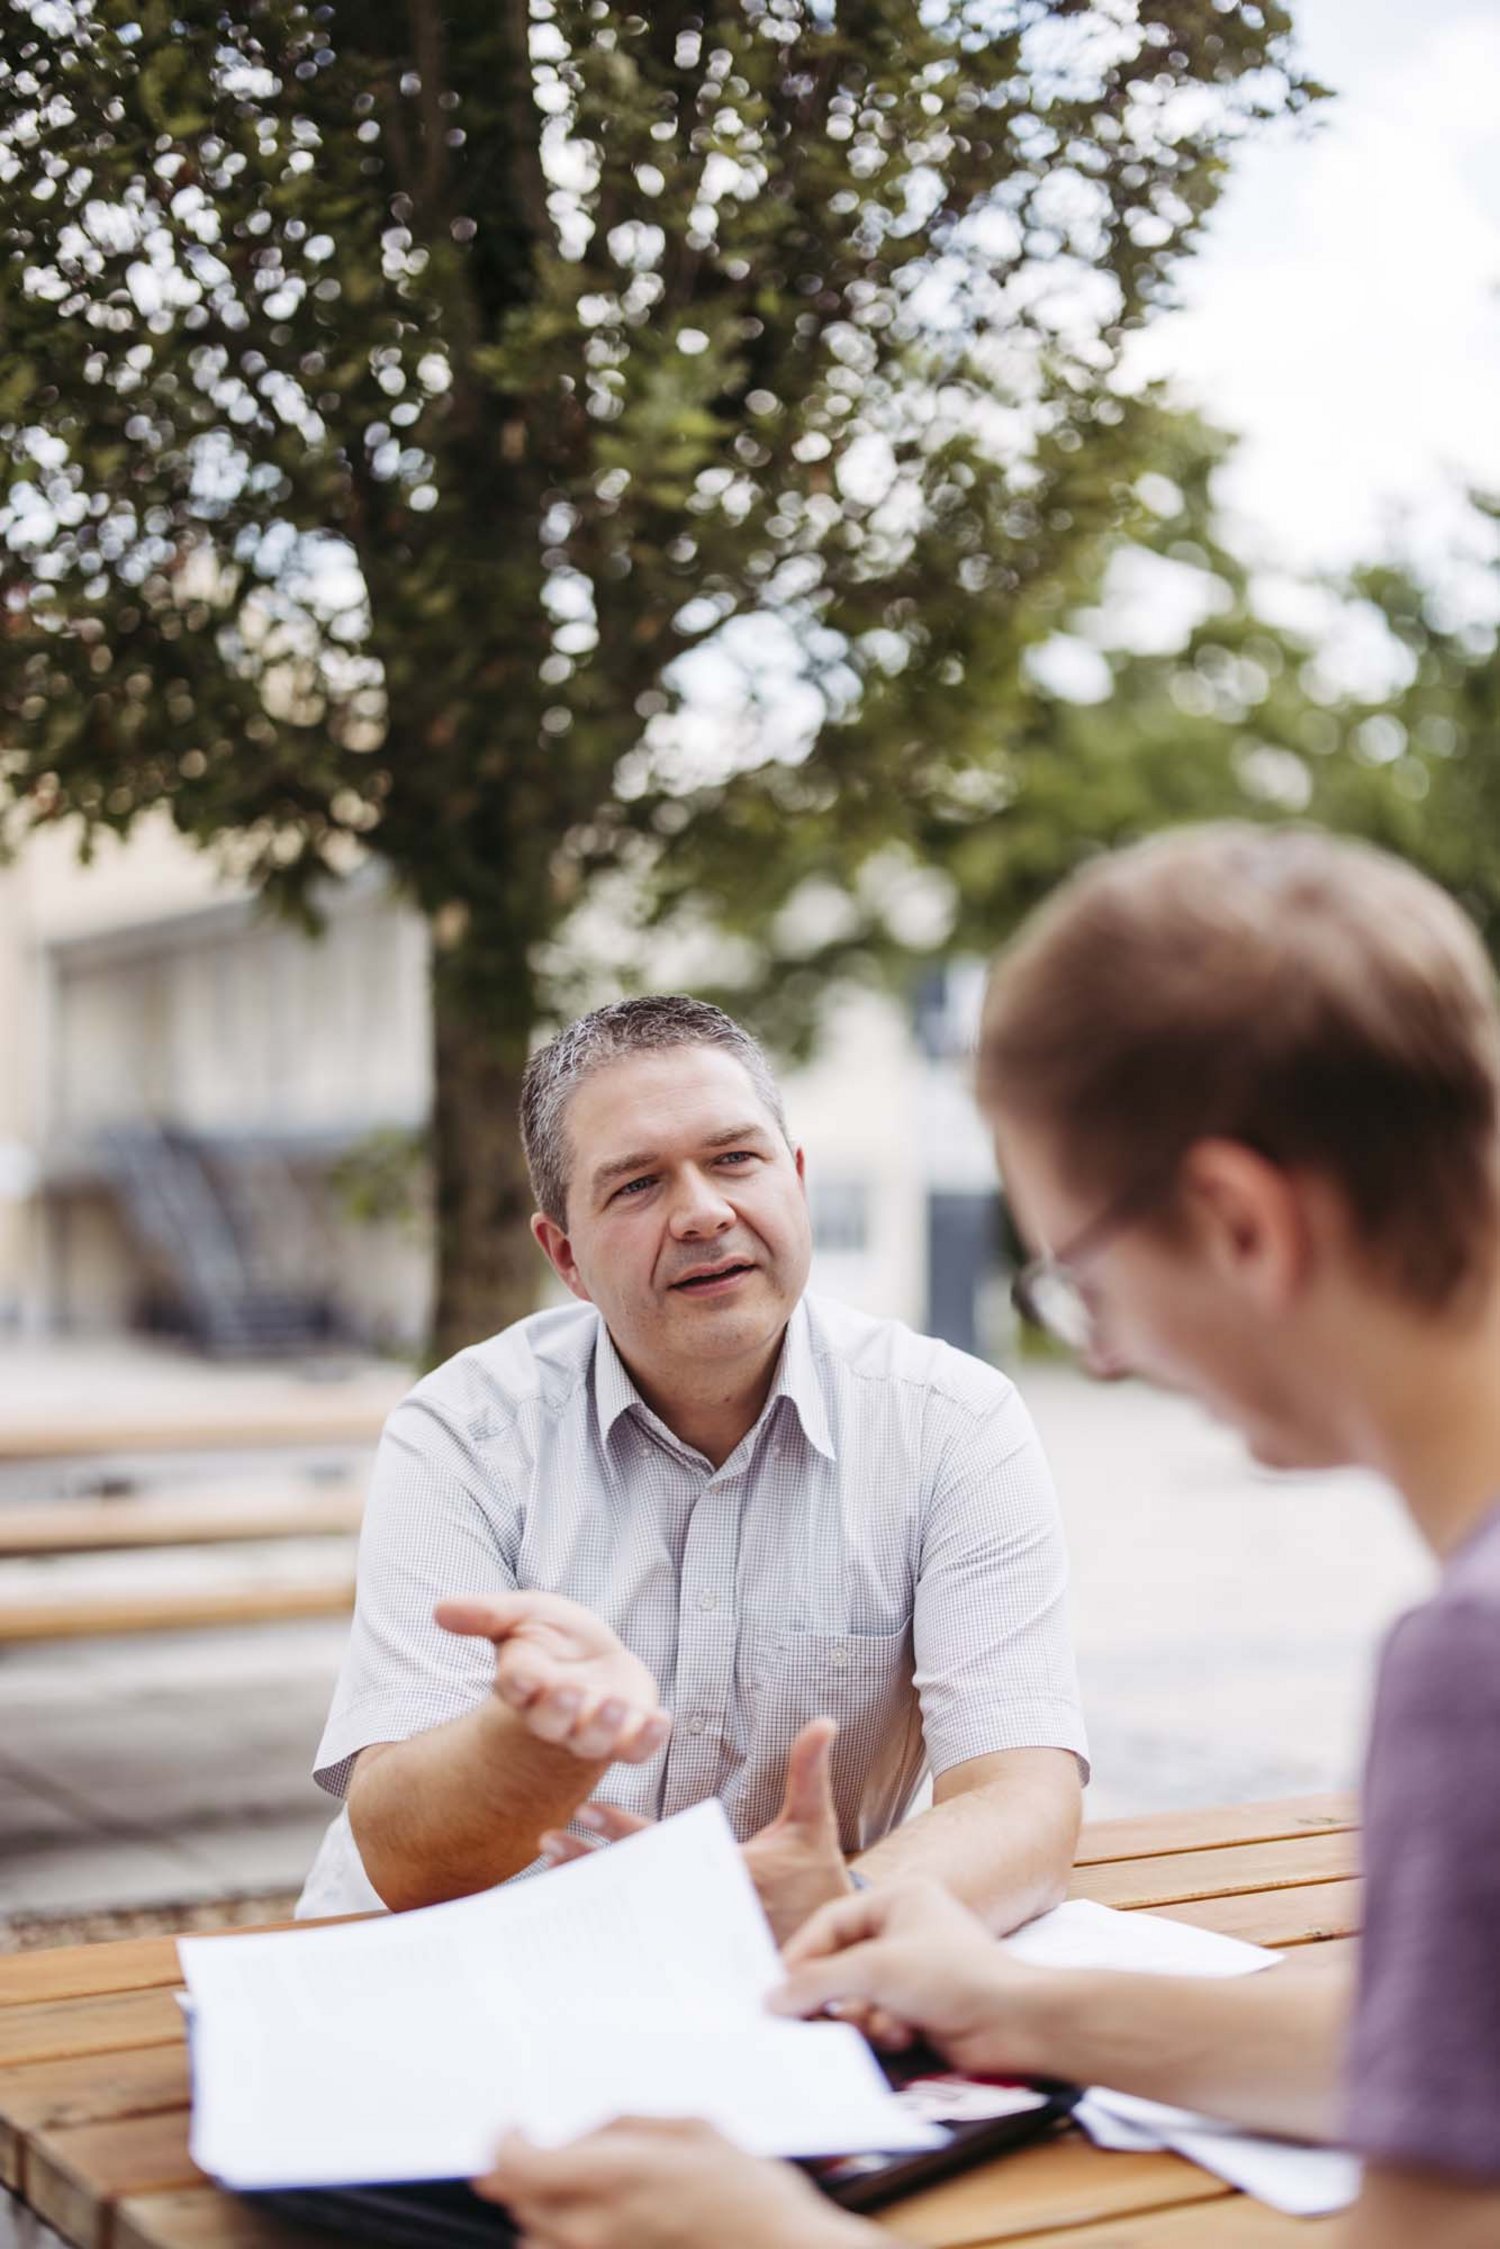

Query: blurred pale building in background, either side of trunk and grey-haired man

[0,828,1005,1352]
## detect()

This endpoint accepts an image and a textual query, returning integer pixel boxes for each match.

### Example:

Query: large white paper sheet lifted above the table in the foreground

[180,1801,942,2188]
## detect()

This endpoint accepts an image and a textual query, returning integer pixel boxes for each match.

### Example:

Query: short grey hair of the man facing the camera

[522,992,789,1226]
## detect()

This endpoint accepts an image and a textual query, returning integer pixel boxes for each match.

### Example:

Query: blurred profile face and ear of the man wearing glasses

[992,1116,1347,1469]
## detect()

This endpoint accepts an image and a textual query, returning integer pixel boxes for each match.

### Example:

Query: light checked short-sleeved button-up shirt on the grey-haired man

[299,1298,1086,1914]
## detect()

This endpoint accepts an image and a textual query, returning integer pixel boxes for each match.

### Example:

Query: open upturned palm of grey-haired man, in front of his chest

[434,1592,672,1765]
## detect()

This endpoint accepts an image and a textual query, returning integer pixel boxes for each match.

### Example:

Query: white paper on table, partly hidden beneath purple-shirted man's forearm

[1005,1898,1361,2218]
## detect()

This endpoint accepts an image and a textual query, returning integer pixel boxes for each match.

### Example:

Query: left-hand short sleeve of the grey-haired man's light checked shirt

[313,1392,526,1797]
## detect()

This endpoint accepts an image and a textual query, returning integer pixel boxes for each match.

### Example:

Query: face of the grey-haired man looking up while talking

[533,1046,812,1394]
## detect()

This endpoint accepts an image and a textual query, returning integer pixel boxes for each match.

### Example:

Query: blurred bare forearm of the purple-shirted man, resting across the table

[1001,1961,1354,2139]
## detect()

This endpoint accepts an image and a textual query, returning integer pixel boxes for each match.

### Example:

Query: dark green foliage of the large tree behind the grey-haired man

[0,0,1307,1017]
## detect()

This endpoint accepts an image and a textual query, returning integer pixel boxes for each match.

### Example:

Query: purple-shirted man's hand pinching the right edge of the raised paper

[771,1882,1046,2076]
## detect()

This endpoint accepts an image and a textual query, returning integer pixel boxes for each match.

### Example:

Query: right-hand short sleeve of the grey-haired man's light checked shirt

[913,1385,1088,1779]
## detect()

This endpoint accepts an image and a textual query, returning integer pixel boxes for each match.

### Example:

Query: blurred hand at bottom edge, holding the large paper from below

[475,2116,868,2249]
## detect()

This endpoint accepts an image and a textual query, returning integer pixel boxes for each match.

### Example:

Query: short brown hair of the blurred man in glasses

[978,823,1500,1304]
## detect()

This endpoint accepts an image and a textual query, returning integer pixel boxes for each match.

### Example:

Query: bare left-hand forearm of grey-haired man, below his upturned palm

[349,1696,609,1912]
